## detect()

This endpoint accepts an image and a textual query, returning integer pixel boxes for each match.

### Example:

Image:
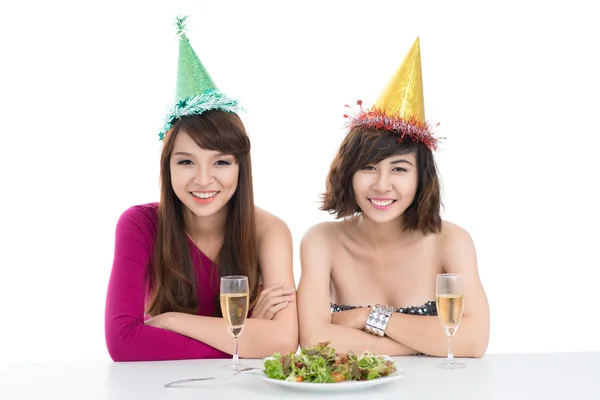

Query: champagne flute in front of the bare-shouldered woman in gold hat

[435,274,466,369]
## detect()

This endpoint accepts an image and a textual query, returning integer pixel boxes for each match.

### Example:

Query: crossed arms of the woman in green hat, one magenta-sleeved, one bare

[105,211,298,361]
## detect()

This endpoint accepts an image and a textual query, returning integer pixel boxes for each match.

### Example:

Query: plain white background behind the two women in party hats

[0,0,600,371]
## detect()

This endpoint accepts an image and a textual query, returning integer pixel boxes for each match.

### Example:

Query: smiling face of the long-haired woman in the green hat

[170,130,239,217]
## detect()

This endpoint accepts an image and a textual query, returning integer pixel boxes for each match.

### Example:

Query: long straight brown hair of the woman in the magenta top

[147,110,259,315]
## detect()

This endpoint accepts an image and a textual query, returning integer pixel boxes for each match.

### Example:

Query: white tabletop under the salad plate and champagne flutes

[0,352,600,400]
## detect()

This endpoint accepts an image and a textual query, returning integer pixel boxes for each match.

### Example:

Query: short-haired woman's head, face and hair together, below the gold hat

[320,127,442,235]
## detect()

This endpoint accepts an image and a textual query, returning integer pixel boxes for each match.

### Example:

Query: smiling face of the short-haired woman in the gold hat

[352,152,419,223]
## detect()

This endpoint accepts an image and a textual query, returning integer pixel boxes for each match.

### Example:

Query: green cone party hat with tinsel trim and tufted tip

[158,16,240,140]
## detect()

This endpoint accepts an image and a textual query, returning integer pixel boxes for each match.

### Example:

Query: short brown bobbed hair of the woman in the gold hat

[320,127,442,235]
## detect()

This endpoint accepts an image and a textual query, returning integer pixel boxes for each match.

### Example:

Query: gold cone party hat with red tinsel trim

[344,38,439,150]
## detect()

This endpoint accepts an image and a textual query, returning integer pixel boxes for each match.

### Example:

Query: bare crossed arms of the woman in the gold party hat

[298,226,489,357]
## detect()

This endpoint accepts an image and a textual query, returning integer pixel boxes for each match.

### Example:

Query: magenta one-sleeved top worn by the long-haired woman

[105,203,230,361]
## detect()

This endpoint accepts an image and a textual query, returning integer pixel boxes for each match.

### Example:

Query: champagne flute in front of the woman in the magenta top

[221,275,249,371]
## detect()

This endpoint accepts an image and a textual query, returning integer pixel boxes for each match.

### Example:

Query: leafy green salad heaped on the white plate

[264,342,396,383]
